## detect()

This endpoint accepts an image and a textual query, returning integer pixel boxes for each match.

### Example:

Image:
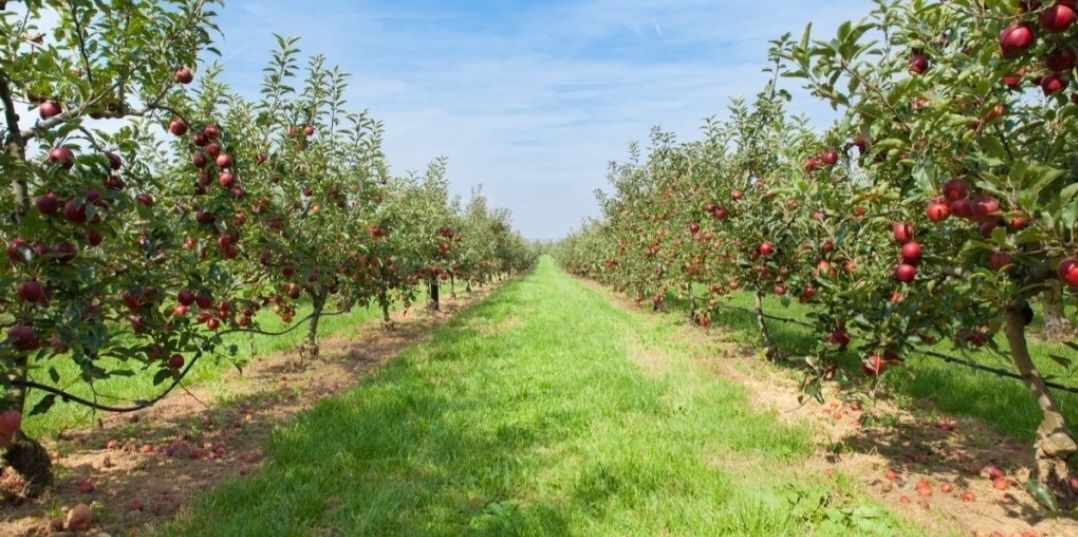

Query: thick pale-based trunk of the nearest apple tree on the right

[1004,302,1078,491]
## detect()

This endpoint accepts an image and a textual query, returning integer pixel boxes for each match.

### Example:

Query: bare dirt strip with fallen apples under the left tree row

[0,287,495,536]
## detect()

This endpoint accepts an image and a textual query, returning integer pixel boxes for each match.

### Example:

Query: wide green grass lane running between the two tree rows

[164,258,918,537]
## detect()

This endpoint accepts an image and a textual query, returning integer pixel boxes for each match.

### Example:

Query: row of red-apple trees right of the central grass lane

[555,0,1078,497]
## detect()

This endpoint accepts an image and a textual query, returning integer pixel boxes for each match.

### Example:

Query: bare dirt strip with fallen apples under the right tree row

[578,279,1078,537]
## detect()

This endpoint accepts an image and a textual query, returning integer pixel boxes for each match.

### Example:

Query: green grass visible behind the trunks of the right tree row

[676,292,1078,441]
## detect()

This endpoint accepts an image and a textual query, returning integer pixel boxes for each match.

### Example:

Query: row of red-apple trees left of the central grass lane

[0,0,534,491]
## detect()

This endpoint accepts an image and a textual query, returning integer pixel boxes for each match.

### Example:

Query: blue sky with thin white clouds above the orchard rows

[210,0,871,238]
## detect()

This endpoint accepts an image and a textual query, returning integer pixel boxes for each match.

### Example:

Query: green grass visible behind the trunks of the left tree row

[24,288,433,438]
